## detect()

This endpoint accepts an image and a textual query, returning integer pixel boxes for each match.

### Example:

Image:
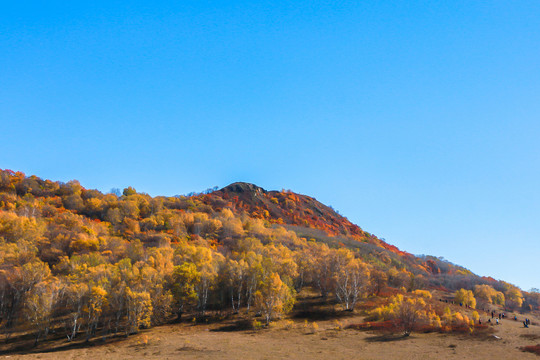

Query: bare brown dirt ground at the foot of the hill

[3,315,540,360]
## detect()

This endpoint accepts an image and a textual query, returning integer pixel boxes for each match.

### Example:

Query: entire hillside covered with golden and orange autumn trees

[0,170,540,351]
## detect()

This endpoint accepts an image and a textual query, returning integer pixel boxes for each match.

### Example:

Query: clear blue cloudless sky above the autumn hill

[0,0,540,289]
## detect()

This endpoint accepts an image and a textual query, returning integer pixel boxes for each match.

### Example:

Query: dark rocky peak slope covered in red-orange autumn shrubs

[193,182,466,274]
